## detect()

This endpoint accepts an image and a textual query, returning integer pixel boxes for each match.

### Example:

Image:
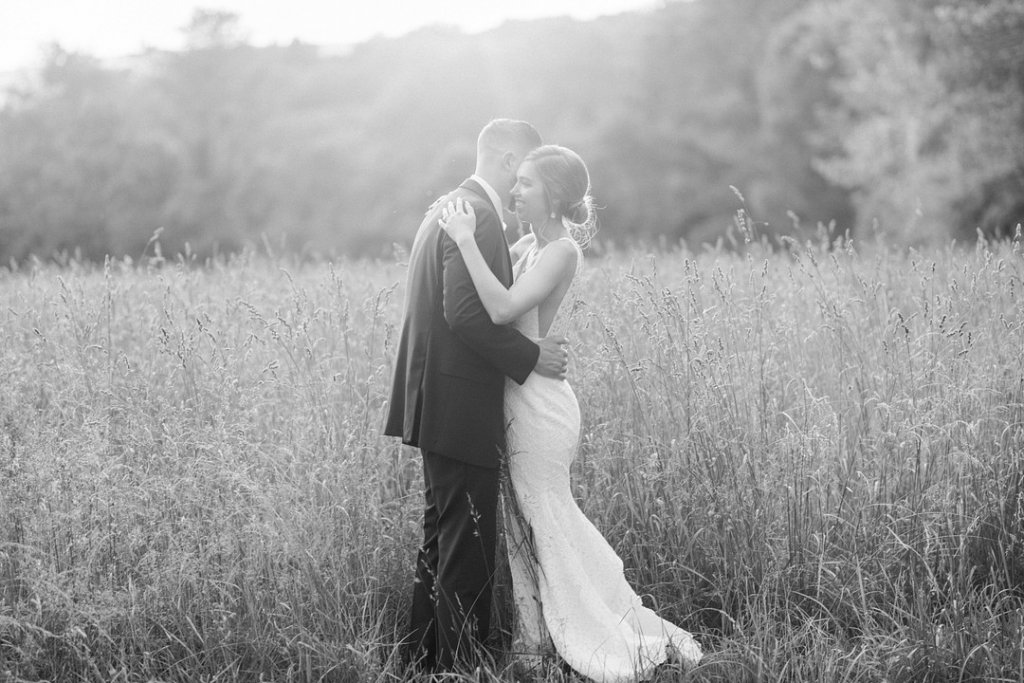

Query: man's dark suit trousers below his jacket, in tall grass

[410,451,499,671]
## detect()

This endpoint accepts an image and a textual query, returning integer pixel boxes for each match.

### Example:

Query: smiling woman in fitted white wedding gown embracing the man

[440,144,701,683]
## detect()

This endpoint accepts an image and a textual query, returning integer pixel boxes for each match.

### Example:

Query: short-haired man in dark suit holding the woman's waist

[384,119,567,671]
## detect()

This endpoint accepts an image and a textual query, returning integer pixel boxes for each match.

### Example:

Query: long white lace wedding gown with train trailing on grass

[505,237,701,683]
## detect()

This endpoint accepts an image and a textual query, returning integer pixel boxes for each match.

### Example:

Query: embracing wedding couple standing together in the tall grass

[385,119,701,683]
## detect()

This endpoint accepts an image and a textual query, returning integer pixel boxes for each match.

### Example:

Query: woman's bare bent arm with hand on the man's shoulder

[441,197,578,325]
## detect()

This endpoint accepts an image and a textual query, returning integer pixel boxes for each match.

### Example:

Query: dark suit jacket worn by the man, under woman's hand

[384,179,540,467]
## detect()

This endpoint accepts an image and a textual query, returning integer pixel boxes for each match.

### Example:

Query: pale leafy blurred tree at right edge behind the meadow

[805,0,1022,244]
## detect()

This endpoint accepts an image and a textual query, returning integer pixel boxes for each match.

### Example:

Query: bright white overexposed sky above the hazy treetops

[0,0,665,72]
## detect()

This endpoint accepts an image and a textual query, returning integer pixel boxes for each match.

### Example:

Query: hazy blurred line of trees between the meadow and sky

[0,0,1024,263]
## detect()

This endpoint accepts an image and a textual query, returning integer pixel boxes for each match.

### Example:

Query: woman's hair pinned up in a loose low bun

[523,144,596,247]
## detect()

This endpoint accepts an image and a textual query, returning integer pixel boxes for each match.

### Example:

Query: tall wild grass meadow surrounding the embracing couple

[0,228,1024,683]
